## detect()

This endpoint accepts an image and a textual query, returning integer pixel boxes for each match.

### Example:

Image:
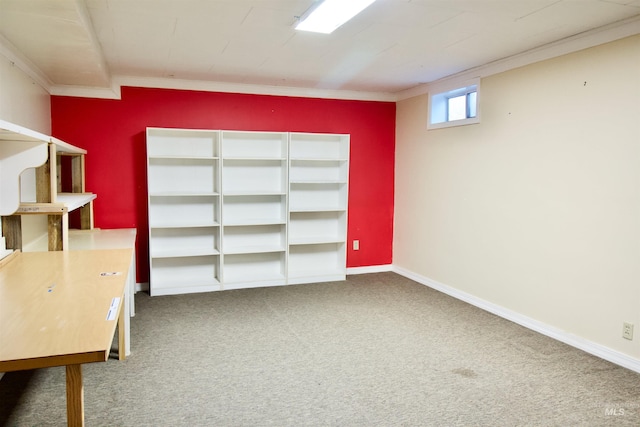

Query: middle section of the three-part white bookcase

[222,131,288,289]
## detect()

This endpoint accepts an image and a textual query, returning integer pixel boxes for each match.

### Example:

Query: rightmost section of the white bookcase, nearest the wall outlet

[288,133,349,284]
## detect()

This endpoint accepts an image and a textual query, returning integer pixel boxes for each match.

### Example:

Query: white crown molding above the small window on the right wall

[396,15,640,101]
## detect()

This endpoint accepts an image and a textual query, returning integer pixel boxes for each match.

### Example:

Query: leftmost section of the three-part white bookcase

[147,128,221,295]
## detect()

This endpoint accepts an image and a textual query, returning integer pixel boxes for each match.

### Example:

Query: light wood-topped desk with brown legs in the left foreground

[0,249,132,426]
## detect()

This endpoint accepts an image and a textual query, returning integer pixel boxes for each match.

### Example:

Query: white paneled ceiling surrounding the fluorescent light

[0,0,640,98]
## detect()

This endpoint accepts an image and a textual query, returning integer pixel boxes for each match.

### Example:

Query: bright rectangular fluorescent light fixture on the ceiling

[296,0,375,34]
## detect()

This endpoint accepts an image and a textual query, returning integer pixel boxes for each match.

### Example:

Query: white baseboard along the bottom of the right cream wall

[392,266,640,373]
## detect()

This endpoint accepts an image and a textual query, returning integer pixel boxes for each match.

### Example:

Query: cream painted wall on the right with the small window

[393,36,640,367]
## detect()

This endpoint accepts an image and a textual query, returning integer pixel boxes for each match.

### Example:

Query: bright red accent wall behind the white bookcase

[51,87,396,282]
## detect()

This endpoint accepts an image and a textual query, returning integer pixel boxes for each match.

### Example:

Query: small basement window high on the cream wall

[427,80,480,129]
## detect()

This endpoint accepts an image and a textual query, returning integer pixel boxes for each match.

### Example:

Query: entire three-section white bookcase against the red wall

[147,128,349,295]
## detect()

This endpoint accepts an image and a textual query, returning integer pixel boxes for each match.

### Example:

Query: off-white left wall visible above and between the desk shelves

[0,54,51,245]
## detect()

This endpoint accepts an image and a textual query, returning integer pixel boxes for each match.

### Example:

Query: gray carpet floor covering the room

[0,273,640,426]
